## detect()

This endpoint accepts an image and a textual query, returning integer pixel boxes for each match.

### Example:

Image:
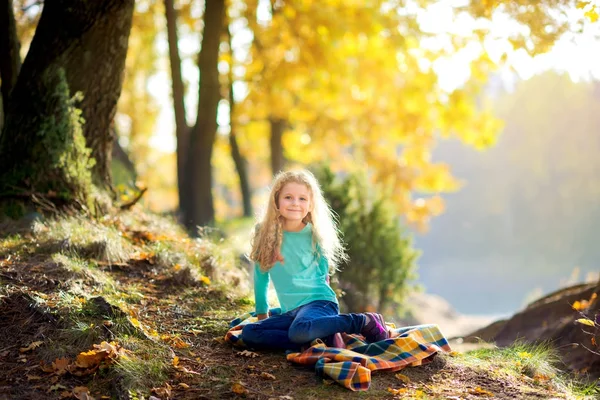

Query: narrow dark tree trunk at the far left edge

[0,0,21,132]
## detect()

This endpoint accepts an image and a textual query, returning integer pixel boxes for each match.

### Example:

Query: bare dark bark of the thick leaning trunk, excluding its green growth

[0,0,134,191]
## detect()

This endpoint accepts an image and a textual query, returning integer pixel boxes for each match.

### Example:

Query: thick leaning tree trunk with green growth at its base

[0,0,134,211]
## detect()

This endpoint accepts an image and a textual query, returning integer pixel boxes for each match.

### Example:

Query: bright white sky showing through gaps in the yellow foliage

[148,0,600,152]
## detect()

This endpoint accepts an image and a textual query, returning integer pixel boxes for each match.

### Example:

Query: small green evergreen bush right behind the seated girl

[315,167,419,315]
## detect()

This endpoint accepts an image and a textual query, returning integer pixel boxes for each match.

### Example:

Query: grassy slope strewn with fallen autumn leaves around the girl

[0,211,594,400]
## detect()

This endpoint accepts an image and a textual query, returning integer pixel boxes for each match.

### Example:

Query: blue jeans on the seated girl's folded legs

[242,300,365,350]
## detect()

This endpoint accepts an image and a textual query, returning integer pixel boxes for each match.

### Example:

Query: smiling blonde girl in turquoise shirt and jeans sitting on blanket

[242,170,389,350]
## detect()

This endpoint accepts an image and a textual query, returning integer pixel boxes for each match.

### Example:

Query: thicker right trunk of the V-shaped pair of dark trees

[184,0,225,230]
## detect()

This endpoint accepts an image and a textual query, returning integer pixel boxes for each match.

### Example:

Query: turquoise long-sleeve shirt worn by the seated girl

[254,223,338,314]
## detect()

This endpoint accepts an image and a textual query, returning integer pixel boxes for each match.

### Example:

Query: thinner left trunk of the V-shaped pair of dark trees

[165,0,190,222]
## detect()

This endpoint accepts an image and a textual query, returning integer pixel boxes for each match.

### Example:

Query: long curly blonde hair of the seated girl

[250,170,348,273]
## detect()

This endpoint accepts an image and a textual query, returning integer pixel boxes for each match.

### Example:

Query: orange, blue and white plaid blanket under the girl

[225,310,450,391]
